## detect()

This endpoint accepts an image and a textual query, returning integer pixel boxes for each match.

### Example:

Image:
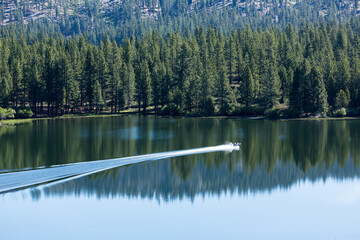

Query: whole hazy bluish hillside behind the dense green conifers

[0,0,360,43]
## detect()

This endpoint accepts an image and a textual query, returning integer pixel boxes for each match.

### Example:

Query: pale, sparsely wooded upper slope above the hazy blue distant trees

[1,0,360,25]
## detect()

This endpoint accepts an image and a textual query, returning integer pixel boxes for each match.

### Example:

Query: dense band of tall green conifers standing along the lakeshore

[0,20,360,114]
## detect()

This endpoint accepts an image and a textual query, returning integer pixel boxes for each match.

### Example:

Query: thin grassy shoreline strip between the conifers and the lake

[0,112,360,127]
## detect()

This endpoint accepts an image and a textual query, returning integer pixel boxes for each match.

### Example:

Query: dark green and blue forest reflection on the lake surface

[0,116,360,200]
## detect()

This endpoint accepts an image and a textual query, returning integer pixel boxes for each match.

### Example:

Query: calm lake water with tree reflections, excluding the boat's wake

[0,116,360,240]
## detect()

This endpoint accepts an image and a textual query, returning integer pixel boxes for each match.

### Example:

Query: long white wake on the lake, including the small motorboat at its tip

[0,144,239,193]
